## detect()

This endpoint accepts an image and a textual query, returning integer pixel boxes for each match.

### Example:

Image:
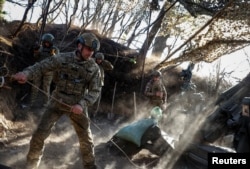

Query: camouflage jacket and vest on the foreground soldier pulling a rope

[23,52,101,107]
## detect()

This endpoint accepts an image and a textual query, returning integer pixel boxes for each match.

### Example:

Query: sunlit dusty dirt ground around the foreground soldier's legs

[0,101,170,169]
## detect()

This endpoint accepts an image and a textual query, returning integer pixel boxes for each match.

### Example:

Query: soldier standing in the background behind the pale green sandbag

[144,71,167,110]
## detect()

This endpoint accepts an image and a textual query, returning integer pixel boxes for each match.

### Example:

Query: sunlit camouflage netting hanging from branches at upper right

[157,0,250,69]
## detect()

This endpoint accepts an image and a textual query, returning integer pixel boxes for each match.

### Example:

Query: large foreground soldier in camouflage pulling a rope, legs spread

[13,33,101,169]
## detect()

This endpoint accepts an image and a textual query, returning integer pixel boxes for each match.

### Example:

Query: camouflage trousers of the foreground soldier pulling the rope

[26,100,95,168]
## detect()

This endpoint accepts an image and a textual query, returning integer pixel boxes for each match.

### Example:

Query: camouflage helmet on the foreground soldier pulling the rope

[76,33,100,51]
